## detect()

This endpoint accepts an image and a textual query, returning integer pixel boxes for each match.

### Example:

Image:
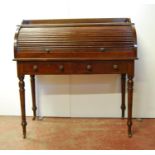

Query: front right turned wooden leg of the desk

[127,75,133,137]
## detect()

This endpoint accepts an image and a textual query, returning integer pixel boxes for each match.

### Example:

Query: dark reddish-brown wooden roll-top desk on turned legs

[14,18,137,138]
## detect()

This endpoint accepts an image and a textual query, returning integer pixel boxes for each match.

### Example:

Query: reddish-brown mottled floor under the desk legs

[0,116,155,150]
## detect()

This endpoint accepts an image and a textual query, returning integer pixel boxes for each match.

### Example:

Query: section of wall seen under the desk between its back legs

[36,74,121,117]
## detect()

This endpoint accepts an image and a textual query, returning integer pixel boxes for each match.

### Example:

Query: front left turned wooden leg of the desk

[18,75,27,138]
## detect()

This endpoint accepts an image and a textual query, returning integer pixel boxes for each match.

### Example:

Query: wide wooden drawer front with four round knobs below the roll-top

[18,61,128,75]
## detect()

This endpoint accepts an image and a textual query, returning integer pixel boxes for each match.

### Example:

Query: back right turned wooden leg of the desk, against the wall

[121,74,126,118]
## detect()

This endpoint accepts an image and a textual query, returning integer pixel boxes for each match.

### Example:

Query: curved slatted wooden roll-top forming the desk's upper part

[15,18,136,59]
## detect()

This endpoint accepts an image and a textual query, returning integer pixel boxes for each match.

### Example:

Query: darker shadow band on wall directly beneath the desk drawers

[37,74,121,95]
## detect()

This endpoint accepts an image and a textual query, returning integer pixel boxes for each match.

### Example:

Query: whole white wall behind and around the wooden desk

[0,0,155,118]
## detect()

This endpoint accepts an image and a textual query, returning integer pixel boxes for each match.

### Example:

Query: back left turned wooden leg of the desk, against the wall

[30,75,37,120]
